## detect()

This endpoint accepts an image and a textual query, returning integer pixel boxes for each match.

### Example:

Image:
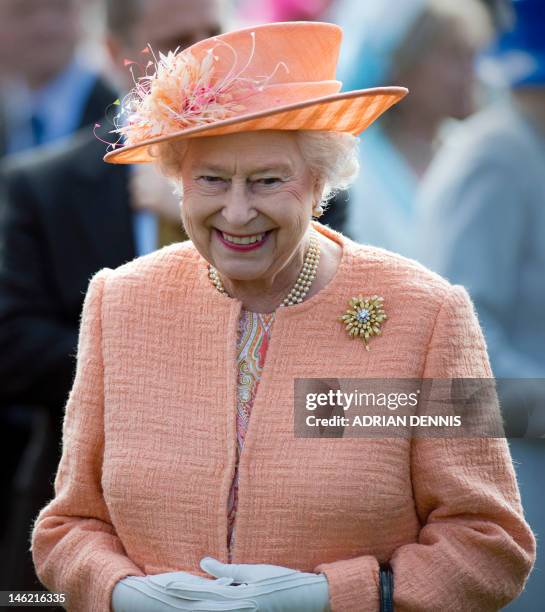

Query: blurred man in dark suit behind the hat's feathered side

[0,0,222,590]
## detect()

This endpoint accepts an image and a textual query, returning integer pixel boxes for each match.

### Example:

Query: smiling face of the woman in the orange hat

[182,131,321,291]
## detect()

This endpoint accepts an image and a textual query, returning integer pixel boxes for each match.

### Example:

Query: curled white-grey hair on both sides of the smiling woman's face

[151,130,359,206]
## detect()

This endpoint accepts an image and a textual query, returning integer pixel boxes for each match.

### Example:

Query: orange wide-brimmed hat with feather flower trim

[104,21,408,164]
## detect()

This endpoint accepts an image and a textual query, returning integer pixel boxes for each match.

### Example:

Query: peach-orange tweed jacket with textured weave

[32,223,535,612]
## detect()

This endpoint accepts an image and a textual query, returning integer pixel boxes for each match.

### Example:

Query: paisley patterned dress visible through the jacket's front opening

[227,309,274,562]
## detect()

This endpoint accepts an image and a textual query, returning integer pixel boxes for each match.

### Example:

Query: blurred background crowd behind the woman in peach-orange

[0,0,545,611]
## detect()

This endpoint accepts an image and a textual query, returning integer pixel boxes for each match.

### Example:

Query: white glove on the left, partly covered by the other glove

[112,572,258,612]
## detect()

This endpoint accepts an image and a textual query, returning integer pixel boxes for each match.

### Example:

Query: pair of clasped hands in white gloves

[112,557,330,612]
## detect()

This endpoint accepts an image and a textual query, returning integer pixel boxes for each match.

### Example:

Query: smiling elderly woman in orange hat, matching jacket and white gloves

[28,23,535,612]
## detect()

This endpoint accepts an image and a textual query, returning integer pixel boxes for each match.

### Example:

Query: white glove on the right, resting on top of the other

[160,557,331,612]
